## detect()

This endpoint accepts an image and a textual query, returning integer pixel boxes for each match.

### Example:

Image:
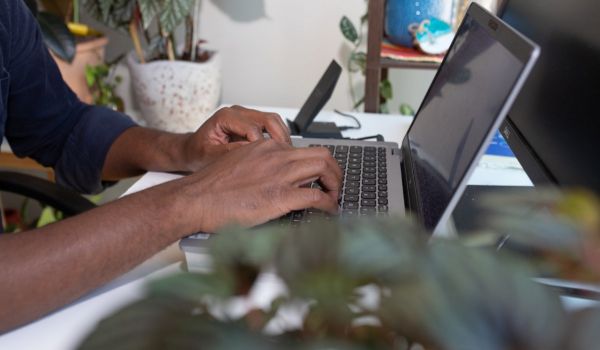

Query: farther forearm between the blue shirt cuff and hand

[102,127,189,180]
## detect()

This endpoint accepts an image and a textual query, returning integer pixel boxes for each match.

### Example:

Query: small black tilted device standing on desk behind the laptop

[288,60,342,139]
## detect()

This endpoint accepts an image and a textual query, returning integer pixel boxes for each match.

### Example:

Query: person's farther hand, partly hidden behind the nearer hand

[184,106,292,171]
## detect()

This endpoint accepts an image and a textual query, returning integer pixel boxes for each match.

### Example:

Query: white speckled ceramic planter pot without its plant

[127,52,221,132]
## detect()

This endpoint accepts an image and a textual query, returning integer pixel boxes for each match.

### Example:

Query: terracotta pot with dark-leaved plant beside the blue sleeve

[27,0,108,103]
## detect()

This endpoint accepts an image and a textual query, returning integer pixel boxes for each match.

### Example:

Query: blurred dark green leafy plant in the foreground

[80,190,600,350]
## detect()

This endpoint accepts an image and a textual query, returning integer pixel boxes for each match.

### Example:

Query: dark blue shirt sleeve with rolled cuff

[0,0,135,193]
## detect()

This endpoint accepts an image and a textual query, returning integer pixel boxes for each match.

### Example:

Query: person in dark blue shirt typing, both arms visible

[0,0,341,332]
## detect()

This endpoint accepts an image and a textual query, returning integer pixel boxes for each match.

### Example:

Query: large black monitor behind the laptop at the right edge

[500,0,600,193]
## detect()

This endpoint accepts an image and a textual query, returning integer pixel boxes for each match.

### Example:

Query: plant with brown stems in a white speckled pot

[86,0,221,132]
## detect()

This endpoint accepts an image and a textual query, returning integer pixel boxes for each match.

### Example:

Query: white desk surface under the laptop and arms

[0,108,587,350]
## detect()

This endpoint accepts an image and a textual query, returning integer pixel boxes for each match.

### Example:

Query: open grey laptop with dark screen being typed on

[181,3,540,263]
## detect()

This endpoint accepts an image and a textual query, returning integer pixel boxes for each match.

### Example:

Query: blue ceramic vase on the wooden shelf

[385,0,454,47]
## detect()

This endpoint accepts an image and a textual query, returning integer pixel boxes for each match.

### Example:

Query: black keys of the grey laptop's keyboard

[279,144,388,225]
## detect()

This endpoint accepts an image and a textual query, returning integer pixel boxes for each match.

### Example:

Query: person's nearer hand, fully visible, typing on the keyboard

[169,140,342,232]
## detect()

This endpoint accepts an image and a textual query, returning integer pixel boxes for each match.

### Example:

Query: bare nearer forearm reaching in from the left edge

[0,179,191,333]
